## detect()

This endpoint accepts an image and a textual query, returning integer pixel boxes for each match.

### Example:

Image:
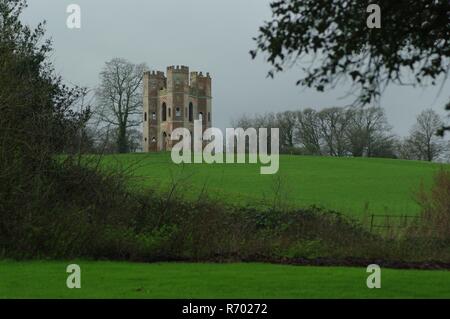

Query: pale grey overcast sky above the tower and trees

[24,0,450,135]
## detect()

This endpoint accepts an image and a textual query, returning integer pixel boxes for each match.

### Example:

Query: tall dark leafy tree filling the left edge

[0,0,89,255]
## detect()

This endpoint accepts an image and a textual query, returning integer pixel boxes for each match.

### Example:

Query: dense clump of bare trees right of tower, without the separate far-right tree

[234,107,398,157]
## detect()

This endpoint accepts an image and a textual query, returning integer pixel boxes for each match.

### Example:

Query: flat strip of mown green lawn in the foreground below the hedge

[0,261,450,298]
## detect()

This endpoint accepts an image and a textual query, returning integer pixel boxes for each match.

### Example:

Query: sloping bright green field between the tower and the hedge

[99,153,440,216]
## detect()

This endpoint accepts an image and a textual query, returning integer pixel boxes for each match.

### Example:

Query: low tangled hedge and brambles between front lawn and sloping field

[0,160,450,264]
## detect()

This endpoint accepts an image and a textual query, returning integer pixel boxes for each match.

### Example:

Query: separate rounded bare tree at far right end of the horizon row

[404,109,445,162]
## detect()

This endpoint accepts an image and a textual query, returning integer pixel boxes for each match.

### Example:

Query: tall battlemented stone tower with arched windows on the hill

[143,66,212,152]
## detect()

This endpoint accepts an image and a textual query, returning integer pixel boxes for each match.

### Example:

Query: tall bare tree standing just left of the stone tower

[96,58,147,153]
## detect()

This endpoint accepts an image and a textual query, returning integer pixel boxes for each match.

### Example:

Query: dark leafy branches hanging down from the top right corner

[251,0,450,104]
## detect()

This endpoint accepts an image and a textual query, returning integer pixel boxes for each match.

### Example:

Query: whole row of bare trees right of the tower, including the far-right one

[233,106,448,161]
